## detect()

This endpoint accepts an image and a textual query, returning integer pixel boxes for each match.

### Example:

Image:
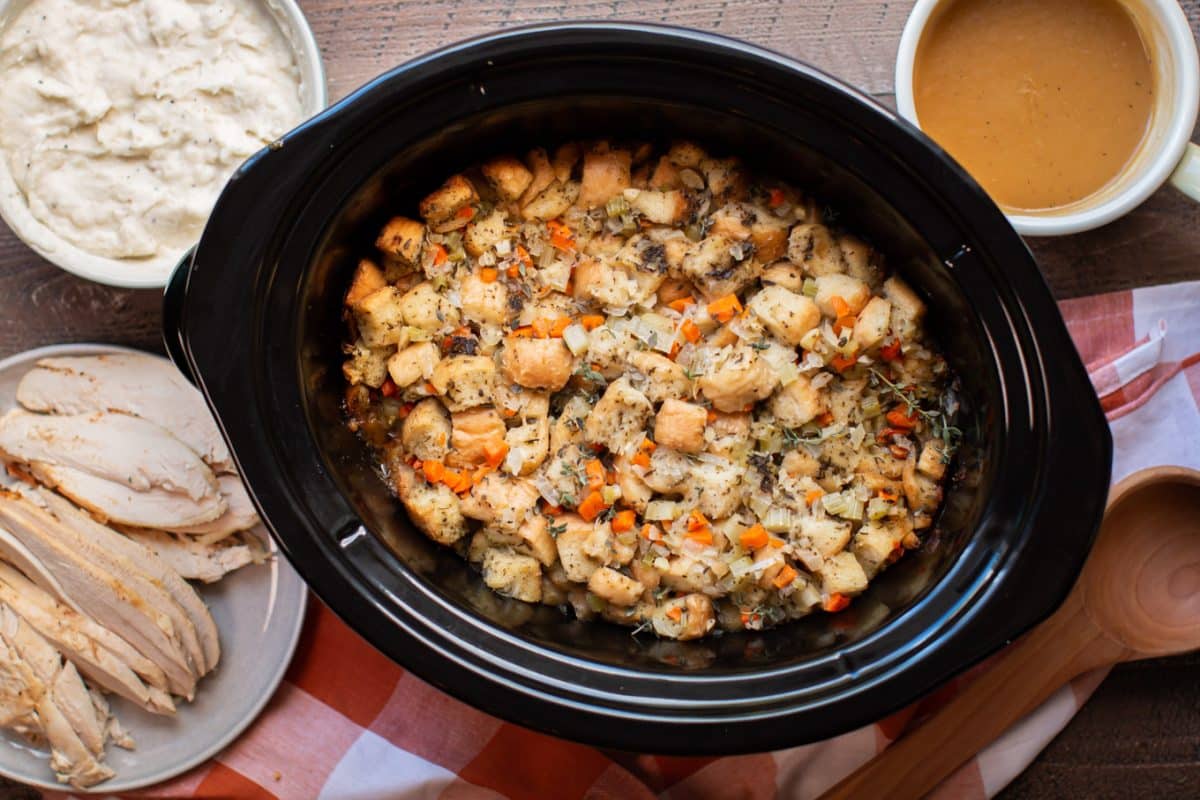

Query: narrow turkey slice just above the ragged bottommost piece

[0,563,175,714]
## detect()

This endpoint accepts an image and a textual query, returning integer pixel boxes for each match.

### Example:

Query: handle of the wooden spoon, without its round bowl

[823,591,1124,800]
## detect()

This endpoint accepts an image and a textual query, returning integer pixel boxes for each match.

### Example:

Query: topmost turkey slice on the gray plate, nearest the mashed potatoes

[17,353,233,473]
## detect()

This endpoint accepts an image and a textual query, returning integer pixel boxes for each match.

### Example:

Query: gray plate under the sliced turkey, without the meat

[0,344,308,794]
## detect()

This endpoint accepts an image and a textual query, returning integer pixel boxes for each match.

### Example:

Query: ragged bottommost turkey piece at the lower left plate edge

[0,637,114,789]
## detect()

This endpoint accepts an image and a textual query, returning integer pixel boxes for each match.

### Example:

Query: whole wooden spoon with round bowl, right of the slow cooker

[823,467,1200,800]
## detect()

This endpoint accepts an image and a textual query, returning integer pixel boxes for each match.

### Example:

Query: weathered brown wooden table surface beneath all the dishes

[0,0,1200,798]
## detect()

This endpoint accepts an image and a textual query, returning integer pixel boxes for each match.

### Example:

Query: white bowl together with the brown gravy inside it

[895,0,1200,236]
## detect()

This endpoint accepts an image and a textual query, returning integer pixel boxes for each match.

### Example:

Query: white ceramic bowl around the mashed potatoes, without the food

[0,0,329,289]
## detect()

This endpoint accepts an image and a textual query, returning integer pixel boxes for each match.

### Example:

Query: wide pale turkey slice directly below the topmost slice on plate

[0,409,226,528]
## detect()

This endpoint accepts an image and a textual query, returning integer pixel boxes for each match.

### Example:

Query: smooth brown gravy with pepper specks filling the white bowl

[913,0,1154,211]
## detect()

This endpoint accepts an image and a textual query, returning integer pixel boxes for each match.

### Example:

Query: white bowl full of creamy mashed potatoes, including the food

[0,0,328,288]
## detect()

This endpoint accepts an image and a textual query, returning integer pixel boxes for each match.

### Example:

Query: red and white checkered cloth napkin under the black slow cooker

[44,282,1200,800]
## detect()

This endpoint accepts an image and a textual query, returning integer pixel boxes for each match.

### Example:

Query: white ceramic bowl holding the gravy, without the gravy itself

[895,0,1200,236]
